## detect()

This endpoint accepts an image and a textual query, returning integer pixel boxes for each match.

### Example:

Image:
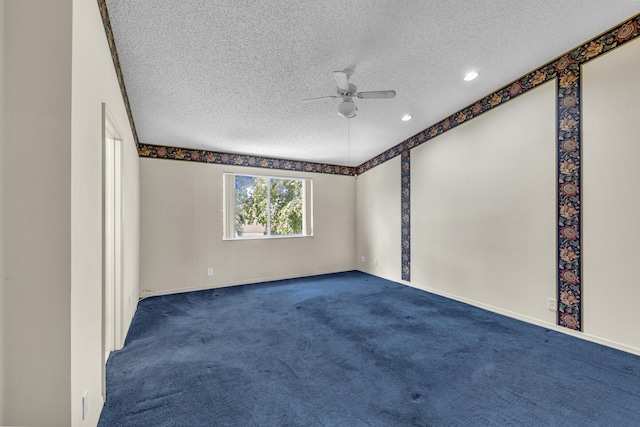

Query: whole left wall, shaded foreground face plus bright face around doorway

[0,0,139,426]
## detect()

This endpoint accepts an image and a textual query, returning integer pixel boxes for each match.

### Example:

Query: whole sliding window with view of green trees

[223,173,313,239]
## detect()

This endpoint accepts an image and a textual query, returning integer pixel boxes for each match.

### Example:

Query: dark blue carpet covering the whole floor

[99,272,640,426]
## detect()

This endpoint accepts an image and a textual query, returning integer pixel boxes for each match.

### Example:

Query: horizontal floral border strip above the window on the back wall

[138,144,356,176]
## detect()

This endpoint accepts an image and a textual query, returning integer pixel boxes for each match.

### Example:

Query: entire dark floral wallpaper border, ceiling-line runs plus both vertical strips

[97,0,640,331]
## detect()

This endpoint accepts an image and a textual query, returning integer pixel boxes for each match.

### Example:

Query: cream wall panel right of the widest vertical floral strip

[582,36,640,354]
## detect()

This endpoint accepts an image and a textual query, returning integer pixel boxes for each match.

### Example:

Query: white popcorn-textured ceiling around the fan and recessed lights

[107,0,640,166]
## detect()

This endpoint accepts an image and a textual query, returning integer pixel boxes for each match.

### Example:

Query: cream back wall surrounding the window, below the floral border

[140,158,355,294]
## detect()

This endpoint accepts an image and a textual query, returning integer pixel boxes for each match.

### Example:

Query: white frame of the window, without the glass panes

[222,172,313,240]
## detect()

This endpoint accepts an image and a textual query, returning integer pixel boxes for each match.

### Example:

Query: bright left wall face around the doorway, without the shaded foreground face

[70,0,139,426]
